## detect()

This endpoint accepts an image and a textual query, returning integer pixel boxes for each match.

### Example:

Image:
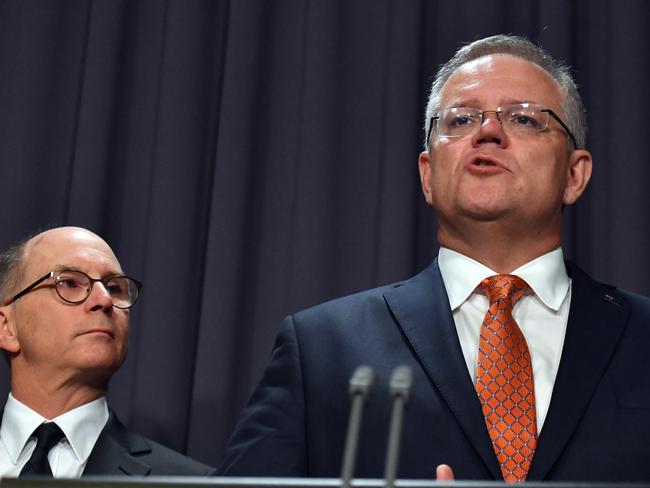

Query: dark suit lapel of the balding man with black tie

[83,411,151,476]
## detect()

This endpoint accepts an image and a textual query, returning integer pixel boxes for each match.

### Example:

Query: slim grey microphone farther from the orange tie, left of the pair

[341,366,375,488]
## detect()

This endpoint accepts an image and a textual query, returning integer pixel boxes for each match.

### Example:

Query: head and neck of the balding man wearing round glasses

[0,227,132,418]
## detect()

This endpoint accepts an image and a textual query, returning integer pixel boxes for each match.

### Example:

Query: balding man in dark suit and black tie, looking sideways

[0,227,212,478]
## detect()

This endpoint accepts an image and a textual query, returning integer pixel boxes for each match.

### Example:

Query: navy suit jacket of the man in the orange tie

[219,261,650,482]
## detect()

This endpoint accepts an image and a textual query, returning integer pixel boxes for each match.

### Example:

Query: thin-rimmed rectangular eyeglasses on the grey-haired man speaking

[427,103,578,149]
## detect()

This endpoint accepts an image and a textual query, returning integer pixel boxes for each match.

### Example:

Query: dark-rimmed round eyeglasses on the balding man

[4,269,142,309]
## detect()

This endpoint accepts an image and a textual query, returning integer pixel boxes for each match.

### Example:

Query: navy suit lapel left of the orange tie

[384,259,501,479]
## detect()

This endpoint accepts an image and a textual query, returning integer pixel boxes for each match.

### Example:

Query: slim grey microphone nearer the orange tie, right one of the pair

[384,365,413,488]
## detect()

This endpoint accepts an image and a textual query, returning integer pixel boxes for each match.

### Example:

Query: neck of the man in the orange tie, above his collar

[438,218,561,274]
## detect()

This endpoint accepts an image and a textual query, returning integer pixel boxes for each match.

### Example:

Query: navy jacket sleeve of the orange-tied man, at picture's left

[218,316,308,476]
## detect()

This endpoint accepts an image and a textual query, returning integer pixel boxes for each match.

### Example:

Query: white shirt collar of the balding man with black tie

[0,393,109,464]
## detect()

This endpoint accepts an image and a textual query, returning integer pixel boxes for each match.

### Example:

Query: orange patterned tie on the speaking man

[476,275,537,483]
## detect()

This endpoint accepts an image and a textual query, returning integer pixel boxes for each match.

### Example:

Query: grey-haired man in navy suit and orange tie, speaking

[220,36,650,482]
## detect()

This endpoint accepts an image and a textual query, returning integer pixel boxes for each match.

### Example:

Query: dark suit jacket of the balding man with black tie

[83,411,214,476]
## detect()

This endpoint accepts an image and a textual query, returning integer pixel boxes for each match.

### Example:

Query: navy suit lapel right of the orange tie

[528,266,629,480]
